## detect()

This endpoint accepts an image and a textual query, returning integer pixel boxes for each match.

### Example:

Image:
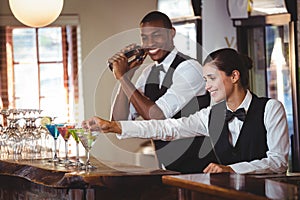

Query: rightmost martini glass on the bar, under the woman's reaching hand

[77,130,99,170]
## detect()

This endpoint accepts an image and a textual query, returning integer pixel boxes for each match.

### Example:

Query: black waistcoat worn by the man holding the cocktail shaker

[145,53,210,173]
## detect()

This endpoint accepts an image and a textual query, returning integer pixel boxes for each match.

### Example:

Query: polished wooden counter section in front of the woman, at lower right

[163,173,300,200]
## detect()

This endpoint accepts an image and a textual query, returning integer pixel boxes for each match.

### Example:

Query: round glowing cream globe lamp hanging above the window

[9,0,64,27]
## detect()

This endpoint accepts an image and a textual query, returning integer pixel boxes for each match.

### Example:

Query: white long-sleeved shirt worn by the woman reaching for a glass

[118,91,289,174]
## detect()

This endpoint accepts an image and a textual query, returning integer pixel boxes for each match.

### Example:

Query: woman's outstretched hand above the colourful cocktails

[81,117,122,134]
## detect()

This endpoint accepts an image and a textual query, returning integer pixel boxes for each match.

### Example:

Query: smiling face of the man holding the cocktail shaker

[140,20,175,62]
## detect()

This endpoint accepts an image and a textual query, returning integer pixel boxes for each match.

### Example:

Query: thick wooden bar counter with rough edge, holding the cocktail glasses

[0,158,178,200]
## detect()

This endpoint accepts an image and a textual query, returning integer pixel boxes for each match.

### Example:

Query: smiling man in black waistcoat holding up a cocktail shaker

[109,11,210,173]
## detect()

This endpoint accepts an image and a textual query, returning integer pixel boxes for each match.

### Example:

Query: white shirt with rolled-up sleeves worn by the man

[129,48,206,119]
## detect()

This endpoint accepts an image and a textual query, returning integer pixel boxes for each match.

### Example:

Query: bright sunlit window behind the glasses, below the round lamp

[1,26,78,122]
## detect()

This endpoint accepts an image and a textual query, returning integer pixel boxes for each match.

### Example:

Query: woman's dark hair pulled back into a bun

[203,48,253,89]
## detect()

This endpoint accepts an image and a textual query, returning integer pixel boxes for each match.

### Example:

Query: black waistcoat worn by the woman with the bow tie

[206,94,269,165]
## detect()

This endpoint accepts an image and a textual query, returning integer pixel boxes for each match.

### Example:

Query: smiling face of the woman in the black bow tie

[203,63,233,103]
